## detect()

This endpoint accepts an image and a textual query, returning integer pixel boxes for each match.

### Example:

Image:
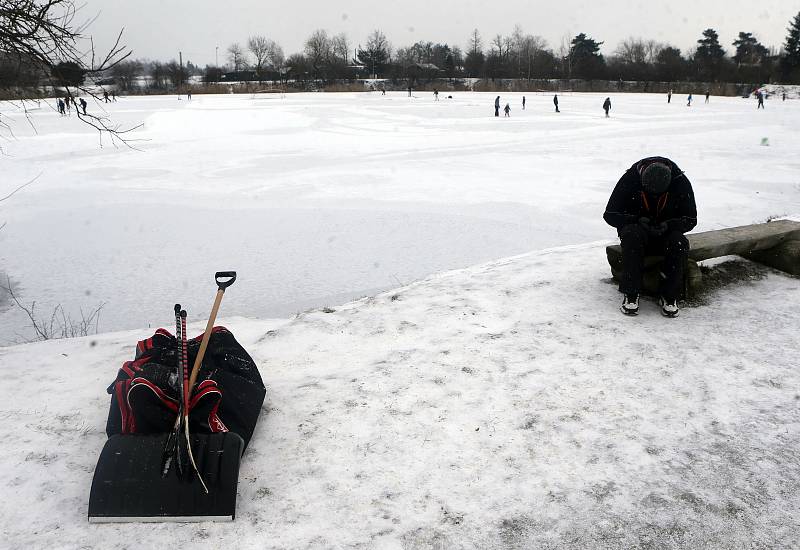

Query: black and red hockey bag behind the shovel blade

[106,327,266,447]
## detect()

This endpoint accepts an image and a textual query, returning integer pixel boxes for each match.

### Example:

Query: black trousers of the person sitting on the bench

[617,224,689,300]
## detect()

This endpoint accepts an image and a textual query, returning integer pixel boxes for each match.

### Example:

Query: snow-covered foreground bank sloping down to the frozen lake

[0,243,800,549]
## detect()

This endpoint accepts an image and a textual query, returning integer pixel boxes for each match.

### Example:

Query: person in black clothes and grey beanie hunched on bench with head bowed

[603,157,697,317]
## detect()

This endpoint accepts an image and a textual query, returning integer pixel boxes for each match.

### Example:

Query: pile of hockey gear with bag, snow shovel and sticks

[88,272,266,523]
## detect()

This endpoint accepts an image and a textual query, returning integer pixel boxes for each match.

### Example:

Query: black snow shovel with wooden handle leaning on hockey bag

[88,271,244,523]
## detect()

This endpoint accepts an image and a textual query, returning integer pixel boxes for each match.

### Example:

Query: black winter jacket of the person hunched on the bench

[603,157,697,233]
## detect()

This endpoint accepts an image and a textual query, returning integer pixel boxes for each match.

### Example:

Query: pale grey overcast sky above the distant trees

[82,0,800,65]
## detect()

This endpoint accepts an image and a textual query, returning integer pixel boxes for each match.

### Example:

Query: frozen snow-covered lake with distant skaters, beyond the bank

[0,93,800,345]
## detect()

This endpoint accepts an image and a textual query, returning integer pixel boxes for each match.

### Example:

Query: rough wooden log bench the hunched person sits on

[606,220,800,297]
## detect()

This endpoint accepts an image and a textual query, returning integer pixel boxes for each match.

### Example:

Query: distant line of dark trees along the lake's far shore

[0,13,800,90]
